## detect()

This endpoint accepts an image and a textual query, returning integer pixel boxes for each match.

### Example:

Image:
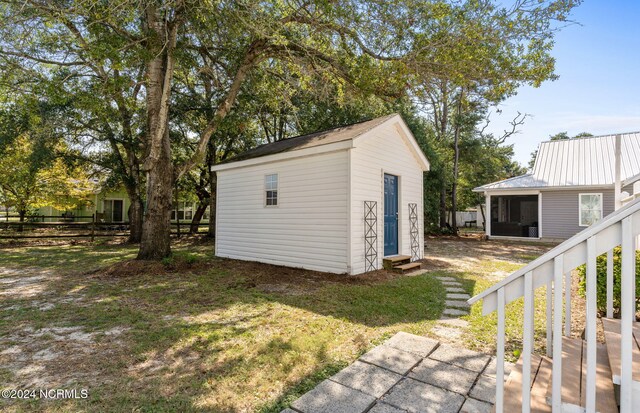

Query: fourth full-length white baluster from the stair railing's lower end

[585,235,598,413]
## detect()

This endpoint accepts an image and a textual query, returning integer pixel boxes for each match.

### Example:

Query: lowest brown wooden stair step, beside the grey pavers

[500,354,551,413]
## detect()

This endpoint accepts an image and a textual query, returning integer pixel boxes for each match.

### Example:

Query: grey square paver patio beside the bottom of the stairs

[282,332,510,413]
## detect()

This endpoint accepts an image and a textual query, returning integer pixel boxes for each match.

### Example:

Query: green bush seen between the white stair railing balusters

[578,247,640,314]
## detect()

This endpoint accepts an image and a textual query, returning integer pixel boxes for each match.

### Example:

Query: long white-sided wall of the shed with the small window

[216,150,348,273]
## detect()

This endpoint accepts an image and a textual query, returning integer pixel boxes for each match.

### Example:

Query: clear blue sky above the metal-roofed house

[487,0,640,166]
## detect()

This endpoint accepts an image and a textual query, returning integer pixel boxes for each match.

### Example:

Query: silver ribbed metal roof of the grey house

[474,132,640,192]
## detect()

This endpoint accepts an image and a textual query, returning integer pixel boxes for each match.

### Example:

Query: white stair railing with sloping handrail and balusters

[469,199,640,413]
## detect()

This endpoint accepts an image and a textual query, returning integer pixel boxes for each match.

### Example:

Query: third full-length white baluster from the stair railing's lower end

[551,255,564,412]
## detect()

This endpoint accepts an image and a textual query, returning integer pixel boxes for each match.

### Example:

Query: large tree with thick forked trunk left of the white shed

[0,0,575,258]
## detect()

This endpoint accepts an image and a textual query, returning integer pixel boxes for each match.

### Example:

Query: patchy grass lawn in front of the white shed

[0,238,444,412]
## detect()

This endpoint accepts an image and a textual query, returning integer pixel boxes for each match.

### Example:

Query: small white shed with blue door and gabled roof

[212,114,429,274]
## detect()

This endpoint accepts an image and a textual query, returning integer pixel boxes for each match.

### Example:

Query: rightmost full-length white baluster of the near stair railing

[620,215,636,413]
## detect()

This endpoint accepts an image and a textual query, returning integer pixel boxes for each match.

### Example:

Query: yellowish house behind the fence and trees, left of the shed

[37,188,209,223]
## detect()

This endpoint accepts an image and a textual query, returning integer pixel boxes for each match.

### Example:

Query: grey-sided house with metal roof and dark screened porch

[474,132,640,240]
